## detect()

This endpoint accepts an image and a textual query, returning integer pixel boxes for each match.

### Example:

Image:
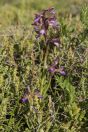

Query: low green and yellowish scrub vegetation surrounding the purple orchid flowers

[0,0,88,132]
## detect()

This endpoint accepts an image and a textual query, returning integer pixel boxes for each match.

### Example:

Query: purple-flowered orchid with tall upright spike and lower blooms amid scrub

[21,8,66,103]
